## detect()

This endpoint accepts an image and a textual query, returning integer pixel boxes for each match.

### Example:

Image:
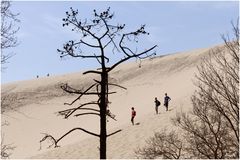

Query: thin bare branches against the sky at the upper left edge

[1,0,20,68]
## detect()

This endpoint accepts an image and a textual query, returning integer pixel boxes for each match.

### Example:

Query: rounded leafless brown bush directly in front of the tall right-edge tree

[173,109,236,159]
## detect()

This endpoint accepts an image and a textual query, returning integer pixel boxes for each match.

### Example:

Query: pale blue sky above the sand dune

[1,1,239,83]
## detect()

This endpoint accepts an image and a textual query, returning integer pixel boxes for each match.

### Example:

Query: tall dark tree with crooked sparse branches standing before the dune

[41,8,157,159]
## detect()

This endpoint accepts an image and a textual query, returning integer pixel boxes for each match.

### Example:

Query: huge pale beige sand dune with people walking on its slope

[1,45,217,159]
